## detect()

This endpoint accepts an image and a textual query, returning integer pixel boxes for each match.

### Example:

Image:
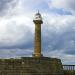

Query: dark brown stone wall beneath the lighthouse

[0,57,63,75]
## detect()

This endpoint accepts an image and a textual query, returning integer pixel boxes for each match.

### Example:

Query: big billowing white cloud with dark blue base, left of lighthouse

[0,23,33,49]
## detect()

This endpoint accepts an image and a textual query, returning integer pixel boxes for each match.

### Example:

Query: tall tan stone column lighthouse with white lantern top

[33,12,43,57]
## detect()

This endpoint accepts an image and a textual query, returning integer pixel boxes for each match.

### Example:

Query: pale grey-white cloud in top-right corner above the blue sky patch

[49,0,75,14]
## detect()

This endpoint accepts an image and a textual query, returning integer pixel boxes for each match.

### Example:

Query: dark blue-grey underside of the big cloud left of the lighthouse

[0,38,33,49]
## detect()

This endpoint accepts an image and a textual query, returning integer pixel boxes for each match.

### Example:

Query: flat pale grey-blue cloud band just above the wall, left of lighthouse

[0,49,32,58]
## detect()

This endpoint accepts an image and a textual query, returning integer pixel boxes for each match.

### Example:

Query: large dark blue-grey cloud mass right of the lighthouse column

[42,16,75,55]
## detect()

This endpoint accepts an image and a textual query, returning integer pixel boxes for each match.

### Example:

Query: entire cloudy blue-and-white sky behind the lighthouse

[0,0,75,64]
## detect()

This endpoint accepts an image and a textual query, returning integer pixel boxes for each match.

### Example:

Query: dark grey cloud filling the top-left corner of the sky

[0,0,16,16]
